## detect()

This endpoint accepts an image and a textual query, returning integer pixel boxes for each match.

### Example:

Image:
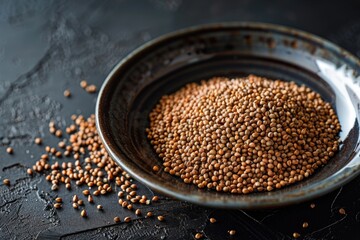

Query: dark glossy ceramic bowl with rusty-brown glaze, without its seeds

[96,22,360,209]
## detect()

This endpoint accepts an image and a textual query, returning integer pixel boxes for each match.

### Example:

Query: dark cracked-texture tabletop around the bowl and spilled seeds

[0,0,360,239]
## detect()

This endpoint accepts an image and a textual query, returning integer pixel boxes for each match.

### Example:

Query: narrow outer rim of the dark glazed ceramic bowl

[95,22,360,209]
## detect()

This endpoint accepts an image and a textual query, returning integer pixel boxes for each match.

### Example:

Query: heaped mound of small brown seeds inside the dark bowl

[146,75,340,194]
